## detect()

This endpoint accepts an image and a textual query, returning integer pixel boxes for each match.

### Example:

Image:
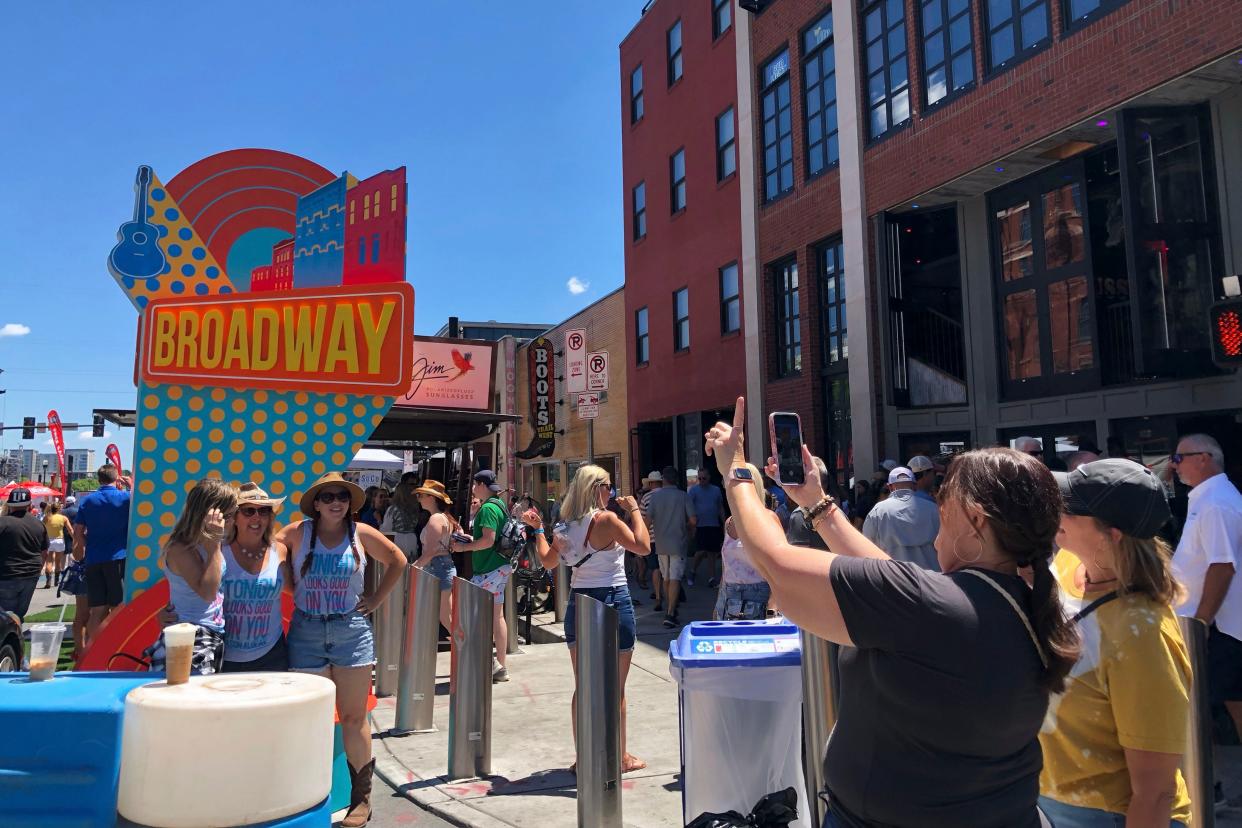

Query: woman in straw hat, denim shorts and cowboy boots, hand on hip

[277,472,406,828]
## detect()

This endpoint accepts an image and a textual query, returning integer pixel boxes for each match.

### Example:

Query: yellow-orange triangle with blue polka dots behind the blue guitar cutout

[117,174,235,312]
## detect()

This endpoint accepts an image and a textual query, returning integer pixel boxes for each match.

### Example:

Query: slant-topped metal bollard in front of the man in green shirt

[448,578,494,780]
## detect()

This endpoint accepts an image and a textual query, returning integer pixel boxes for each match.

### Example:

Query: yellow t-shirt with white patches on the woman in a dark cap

[1040,550,1190,823]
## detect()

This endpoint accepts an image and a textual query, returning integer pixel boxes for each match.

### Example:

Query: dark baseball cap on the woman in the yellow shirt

[1052,458,1172,539]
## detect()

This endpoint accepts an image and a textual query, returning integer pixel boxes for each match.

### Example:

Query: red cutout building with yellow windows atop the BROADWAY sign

[344,166,406,284]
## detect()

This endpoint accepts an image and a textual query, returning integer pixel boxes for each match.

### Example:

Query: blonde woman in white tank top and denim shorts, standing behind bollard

[522,466,651,773]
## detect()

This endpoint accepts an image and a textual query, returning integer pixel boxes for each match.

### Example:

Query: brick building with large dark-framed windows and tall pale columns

[737,0,1242,482]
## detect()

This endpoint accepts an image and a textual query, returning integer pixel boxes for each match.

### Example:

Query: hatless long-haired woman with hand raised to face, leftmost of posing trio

[145,477,237,675]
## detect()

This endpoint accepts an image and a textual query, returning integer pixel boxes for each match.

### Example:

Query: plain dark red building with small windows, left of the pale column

[620,0,754,479]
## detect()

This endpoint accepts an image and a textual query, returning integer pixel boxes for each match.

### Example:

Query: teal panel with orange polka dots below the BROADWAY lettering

[125,382,394,600]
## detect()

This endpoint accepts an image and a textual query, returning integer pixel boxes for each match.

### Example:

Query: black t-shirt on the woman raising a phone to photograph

[823,557,1048,828]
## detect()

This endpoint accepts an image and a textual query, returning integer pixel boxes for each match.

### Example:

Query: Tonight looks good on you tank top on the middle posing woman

[220,544,284,662]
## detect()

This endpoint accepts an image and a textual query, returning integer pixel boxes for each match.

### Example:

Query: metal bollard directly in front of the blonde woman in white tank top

[575,595,621,828]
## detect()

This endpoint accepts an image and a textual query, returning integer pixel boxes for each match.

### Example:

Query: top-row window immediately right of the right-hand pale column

[862,0,914,140]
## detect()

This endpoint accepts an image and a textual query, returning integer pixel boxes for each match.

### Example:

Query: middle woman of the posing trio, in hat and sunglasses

[221,483,291,673]
